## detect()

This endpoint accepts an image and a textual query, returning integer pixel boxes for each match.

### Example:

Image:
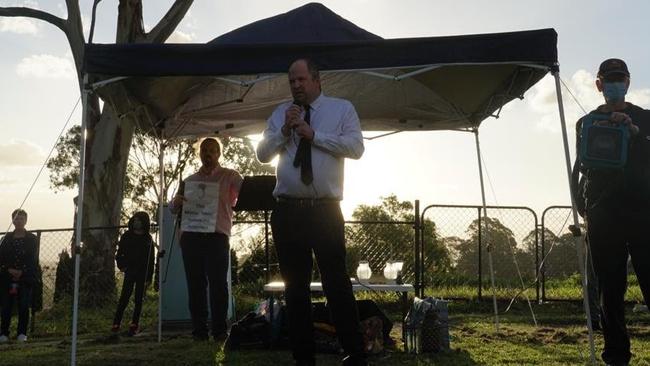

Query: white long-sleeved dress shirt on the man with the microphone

[257,94,364,200]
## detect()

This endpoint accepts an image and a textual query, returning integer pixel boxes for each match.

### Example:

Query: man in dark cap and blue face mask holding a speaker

[576,58,650,365]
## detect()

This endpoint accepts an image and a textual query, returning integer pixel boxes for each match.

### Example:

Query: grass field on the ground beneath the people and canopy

[0,301,650,366]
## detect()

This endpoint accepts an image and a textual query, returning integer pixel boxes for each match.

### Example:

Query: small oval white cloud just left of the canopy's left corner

[16,54,77,79]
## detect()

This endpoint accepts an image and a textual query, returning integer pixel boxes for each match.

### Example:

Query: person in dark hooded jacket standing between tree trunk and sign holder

[111,211,155,336]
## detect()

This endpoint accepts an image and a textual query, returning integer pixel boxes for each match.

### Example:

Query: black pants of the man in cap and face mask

[587,205,650,363]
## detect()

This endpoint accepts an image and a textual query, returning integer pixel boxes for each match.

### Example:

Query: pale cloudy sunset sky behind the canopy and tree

[0,0,650,231]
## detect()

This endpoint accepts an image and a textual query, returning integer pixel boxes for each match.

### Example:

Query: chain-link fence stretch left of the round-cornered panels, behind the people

[0,220,414,337]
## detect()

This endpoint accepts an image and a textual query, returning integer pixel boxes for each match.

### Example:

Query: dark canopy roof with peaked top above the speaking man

[84,3,557,136]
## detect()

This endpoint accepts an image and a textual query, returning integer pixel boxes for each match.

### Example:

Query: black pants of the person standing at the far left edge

[0,280,32,337]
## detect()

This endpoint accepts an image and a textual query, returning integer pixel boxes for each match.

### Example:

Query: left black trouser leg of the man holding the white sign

[181,232,208,338]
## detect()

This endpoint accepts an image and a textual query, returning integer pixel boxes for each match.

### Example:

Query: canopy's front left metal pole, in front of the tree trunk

[70,74,90,366]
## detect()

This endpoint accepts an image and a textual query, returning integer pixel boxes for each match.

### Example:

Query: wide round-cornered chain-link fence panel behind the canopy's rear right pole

[421,205,539,299]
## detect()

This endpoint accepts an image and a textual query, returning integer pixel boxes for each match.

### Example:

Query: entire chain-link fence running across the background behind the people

[6,205,616,336]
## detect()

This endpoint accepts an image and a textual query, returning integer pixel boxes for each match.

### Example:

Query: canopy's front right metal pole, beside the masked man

[552,66,596,365]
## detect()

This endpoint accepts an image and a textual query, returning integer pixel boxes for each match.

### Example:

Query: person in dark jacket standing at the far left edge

[0,209,38,343]
